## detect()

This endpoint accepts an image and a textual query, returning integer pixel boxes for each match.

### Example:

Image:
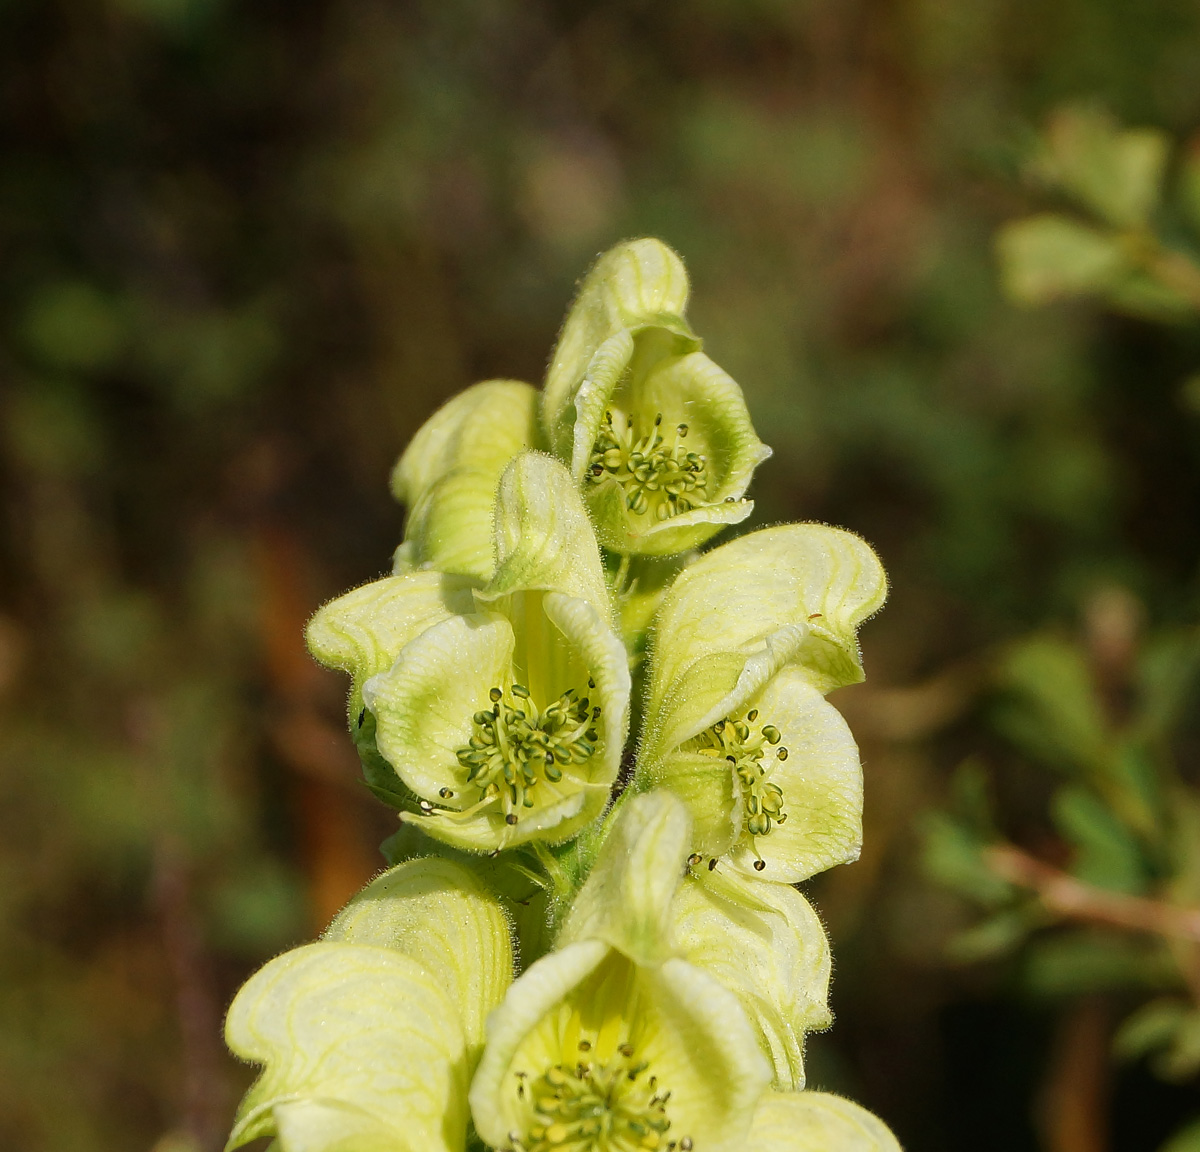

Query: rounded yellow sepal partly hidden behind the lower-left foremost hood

[324,857,514,1064]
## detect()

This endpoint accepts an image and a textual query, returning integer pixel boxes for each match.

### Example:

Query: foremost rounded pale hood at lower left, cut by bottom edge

[226,943,467,1152]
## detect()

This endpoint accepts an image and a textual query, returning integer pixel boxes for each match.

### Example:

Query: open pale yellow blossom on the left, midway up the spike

[308,452,630,851]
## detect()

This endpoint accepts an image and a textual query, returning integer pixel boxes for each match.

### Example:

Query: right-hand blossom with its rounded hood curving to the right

[636,524,887,883]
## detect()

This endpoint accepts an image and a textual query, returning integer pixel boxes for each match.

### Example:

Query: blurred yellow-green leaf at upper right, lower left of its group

[996,212,1132,305]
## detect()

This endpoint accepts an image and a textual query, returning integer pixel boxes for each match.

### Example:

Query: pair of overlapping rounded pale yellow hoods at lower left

[226,859,512,1152]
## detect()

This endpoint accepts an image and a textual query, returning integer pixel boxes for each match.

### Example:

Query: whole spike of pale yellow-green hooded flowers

[227,240,898,1152]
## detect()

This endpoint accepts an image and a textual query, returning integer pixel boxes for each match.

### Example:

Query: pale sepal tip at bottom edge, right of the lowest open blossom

[743,1092,900,1152]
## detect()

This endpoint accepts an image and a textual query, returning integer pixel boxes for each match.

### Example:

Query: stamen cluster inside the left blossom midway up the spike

[455,680,600,824]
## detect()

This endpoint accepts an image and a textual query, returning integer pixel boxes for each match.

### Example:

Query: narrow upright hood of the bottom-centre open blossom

[559,791,691,965]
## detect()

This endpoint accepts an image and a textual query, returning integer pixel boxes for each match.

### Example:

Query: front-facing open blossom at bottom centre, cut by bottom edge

[470,793,770,1152]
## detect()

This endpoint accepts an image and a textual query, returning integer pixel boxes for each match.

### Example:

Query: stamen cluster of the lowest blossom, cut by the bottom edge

[512,1040,691,1152]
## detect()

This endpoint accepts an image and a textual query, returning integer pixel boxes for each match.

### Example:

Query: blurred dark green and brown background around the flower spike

[7,0,1200,1152]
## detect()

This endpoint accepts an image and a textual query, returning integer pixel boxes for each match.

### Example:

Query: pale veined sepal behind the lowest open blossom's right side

[672,864,833,1091]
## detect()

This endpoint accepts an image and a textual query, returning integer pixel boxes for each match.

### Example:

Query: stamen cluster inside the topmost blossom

[588,409,708,520]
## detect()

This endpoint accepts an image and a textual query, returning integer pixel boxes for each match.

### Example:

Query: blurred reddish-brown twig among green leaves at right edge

[984,845,1200,943]
